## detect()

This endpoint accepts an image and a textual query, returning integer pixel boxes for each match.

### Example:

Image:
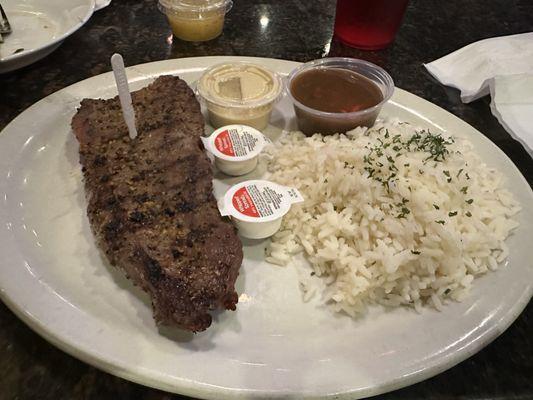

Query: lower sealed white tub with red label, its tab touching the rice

[219,180,304,239]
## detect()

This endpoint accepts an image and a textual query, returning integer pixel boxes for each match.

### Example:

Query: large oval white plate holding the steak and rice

[0,57,533,399]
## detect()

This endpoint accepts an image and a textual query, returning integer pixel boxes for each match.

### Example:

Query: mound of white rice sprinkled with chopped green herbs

[266,122,520,316]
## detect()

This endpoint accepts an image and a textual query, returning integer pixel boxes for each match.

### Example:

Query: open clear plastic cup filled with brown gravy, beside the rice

[287,57,394,135]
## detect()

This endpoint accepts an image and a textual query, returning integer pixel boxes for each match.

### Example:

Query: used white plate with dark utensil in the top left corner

[0,0,109,73]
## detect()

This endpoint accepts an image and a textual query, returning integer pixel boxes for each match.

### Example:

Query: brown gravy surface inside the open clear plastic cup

[290,68,383,113]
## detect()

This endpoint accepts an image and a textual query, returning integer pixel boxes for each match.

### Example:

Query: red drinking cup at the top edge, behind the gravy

[335,0,409,50]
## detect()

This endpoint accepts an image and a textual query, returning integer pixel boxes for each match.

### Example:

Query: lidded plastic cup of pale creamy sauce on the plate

[197,62,283,130]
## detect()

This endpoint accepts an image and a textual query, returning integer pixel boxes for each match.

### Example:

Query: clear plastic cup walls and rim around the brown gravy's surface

[287,57,394,136]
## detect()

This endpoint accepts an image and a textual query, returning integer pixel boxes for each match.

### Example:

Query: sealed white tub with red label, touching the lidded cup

[202,125,268,176]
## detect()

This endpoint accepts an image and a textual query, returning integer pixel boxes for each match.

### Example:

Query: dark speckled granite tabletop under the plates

[0,0,533,400]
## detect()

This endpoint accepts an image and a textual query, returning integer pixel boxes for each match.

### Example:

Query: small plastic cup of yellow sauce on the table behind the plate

[159,0,233,42]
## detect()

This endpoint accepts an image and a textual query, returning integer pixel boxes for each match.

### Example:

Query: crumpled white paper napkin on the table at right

[424,32,533,156]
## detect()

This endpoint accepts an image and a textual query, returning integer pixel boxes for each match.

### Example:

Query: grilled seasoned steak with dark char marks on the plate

[72,76,242,332]
